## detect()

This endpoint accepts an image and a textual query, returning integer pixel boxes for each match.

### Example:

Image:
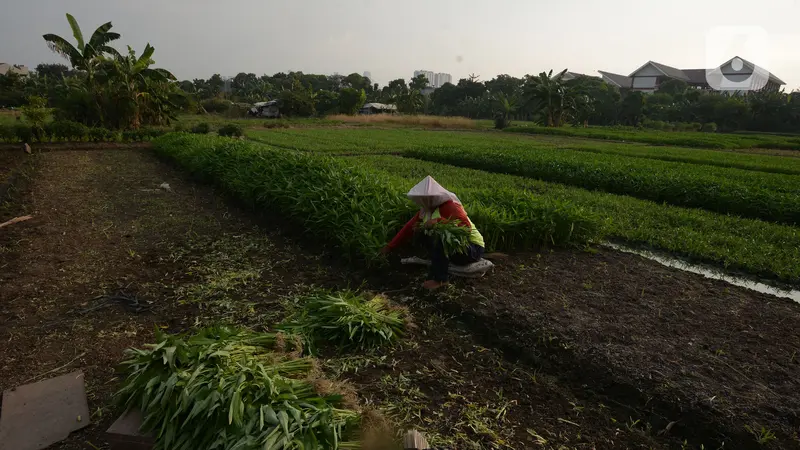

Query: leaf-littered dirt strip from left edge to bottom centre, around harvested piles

[0,149,678,449]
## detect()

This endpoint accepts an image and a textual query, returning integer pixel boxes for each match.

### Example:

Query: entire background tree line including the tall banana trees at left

[0,14,800,132]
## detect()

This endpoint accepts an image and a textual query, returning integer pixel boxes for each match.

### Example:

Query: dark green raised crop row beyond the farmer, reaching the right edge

[403,148,800,224]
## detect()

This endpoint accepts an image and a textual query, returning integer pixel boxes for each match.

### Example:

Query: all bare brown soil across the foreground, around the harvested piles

[0,146,800,449]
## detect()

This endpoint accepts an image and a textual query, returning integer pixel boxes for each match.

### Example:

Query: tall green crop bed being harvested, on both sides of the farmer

[154,134,600,264]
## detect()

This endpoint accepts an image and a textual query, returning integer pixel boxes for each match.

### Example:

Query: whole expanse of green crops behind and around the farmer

[156,128,800,282]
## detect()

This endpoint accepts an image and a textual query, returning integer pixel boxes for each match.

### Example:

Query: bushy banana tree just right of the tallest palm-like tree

[106,44,175,129]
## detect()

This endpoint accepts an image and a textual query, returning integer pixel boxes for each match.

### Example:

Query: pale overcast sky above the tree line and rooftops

[0,0,800,91]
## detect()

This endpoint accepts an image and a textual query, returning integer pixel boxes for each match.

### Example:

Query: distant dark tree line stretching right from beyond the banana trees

[179,70,800,132]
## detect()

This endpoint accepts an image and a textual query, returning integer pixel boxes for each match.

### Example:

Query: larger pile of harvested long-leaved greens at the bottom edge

[117,327,359,450]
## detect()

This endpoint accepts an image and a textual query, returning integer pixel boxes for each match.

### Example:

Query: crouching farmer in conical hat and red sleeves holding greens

[381,176,484,290]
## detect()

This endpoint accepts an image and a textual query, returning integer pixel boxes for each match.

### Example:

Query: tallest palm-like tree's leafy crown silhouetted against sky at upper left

[42,14,120,85]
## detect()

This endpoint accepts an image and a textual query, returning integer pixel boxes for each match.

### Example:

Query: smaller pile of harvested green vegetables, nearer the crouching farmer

[285,291,408,350]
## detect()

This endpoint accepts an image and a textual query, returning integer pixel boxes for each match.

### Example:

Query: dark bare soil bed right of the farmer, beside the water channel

[410,251,800,448]
